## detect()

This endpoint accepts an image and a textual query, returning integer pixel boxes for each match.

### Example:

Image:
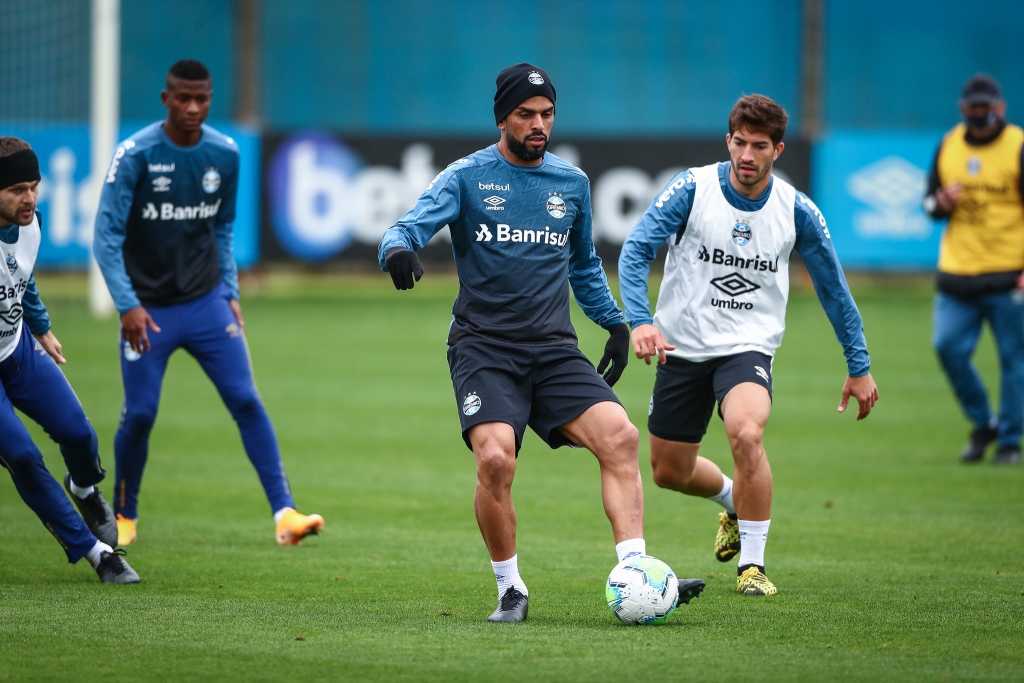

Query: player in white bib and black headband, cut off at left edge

[0,137,139,584]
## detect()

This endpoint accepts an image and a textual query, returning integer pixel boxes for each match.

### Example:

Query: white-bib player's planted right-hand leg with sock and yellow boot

[721,382,776,595]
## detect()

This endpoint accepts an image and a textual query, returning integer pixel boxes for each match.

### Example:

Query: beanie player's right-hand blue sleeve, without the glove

[569,185,623,329]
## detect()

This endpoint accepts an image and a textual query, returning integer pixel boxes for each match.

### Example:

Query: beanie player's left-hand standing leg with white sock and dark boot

[469,422,529,622]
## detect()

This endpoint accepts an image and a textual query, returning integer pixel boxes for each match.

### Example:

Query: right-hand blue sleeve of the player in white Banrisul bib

[794,191,871,377]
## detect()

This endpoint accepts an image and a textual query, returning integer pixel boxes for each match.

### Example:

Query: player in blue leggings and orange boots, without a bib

[93,59,324,546]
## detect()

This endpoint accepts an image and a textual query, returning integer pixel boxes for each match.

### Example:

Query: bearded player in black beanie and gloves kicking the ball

[379,63,703,622]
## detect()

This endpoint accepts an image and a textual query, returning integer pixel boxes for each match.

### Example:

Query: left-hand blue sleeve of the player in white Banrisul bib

[618,171,696,328]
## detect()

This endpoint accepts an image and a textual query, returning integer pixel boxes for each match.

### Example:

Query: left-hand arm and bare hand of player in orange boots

[92,143,160,353]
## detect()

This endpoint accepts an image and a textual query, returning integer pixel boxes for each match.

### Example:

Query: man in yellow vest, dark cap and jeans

[925,74,1024,465]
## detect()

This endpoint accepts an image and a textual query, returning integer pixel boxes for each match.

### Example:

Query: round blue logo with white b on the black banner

[267,133,364,261]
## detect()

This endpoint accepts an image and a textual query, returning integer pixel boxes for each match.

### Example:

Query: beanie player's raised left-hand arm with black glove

[377,167,460,290]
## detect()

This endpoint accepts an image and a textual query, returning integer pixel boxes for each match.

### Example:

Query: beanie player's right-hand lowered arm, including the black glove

[569,183,630,386]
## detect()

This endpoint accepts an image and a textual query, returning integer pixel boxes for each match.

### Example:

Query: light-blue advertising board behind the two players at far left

[0,122,260,268]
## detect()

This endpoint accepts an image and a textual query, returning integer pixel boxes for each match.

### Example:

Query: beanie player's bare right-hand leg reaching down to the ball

[561,401,643,544]
